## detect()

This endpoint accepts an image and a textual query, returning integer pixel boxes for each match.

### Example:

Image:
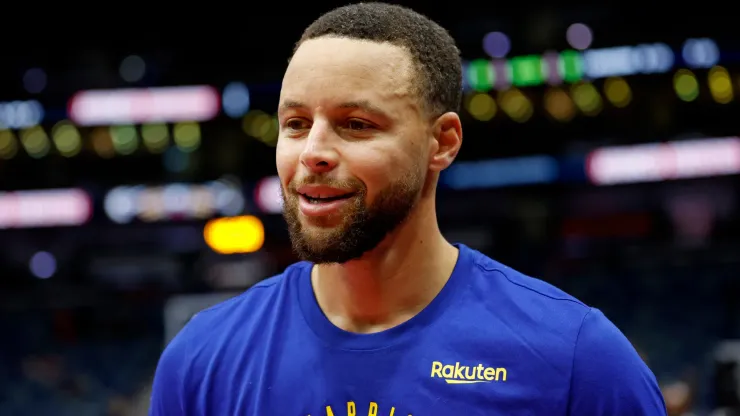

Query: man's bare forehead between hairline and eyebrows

[281,37,413,109]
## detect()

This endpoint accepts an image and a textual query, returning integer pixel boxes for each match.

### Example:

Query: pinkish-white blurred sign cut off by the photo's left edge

[0,189,92,228]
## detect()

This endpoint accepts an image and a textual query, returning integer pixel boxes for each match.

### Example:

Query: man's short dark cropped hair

[293,3,462,115]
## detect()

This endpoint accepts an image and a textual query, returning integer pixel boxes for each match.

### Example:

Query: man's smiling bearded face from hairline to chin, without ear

[276,37,431,263]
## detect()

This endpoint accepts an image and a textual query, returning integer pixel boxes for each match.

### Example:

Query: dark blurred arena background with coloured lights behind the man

[0,1,740,416]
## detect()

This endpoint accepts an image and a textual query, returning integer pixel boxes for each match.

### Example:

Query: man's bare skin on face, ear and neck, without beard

[276,37,462,333]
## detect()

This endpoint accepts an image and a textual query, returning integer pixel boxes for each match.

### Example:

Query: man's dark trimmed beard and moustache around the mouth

[281,172,424,264]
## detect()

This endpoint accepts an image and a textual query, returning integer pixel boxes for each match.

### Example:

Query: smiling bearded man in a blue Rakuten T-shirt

[150,3,665,416]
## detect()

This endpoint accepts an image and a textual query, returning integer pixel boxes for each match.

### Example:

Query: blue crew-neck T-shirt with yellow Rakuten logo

[150,245,666,416]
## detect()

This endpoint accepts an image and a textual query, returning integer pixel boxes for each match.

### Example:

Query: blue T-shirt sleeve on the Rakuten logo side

[568,309,666,416]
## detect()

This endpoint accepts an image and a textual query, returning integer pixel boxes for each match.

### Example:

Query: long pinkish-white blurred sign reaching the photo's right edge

[586,137,740,185]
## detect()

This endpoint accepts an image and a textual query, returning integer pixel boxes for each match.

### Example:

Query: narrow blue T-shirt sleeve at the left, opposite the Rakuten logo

[149,336,189,416]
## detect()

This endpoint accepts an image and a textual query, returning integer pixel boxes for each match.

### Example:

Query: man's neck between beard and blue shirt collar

[311,197,458,333]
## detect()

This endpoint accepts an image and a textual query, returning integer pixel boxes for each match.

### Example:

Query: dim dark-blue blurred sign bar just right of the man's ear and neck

[440,156,560,190]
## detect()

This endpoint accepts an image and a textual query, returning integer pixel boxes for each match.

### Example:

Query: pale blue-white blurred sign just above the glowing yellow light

[104,181,245,224]
